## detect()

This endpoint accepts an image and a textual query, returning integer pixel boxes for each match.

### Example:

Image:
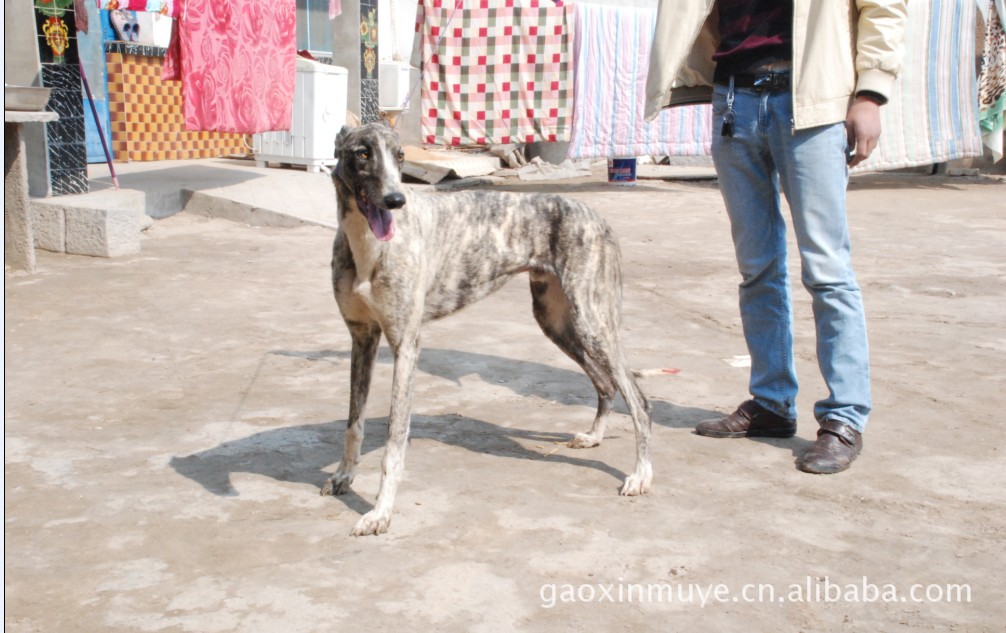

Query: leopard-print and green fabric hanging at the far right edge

[978,0,1006,162]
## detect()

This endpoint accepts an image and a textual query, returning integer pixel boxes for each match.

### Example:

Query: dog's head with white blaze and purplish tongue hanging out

[332,123,405,242]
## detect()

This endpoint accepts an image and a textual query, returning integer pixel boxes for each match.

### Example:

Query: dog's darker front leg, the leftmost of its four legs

[321,322,381,494]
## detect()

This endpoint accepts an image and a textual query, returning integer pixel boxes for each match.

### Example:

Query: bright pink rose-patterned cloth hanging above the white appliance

[162,0,297,134]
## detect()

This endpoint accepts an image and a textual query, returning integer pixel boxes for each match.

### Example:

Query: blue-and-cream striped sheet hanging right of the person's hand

[856,0,982,171]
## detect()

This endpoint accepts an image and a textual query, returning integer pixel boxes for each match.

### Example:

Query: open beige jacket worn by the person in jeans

[646,0,907,130]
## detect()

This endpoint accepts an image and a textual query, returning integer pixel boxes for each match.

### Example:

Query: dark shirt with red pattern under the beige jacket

[712,0,793,80]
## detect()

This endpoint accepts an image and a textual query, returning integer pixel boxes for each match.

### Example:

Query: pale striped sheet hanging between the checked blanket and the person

[567,3,712,160]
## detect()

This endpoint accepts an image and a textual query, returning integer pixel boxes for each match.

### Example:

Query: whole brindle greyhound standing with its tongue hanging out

[321,124,653,535]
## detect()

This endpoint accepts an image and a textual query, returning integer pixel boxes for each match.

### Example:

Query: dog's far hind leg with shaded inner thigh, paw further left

[531,272,617,449]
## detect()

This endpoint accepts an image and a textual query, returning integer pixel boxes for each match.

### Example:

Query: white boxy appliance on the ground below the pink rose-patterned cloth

[252,57,349,172]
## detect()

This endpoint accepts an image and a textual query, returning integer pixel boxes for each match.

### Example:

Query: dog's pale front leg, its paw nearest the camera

[353,334,420,536]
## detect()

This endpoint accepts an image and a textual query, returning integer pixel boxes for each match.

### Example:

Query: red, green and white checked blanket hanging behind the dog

[413,0,573,146]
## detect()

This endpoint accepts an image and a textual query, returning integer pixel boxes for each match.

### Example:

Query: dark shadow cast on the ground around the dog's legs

[170,348,710,513]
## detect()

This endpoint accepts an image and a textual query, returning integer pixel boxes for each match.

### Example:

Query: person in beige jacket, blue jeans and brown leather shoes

[646,0,907,474]
